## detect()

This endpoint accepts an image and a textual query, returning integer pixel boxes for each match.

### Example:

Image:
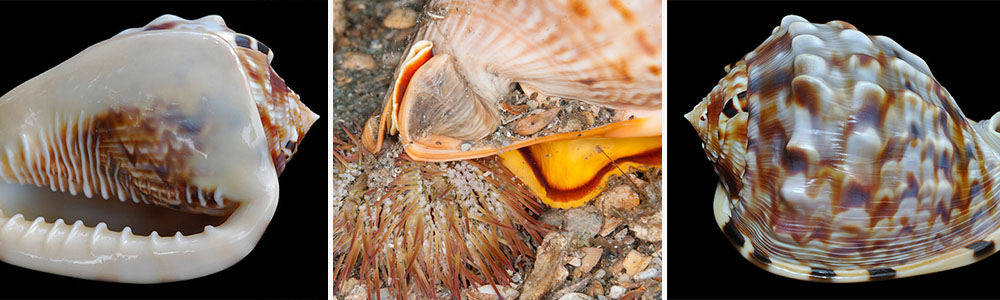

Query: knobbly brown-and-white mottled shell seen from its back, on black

[685,15,1000,282]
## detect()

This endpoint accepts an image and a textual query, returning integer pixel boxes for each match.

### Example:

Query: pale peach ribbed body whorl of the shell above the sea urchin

[415,0,661,109]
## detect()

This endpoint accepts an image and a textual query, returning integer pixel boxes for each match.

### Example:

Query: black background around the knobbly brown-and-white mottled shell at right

[665,2,1000,298]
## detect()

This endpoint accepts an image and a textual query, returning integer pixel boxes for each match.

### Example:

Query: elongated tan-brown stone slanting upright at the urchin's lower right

[520,232,569,300]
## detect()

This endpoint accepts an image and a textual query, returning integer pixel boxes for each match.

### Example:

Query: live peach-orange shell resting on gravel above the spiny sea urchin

[362,0,662,209]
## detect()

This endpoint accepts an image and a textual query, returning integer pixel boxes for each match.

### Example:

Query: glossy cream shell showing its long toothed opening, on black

[0,15,318,283]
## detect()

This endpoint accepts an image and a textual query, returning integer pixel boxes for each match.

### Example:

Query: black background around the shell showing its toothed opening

[0,1,329,298]
